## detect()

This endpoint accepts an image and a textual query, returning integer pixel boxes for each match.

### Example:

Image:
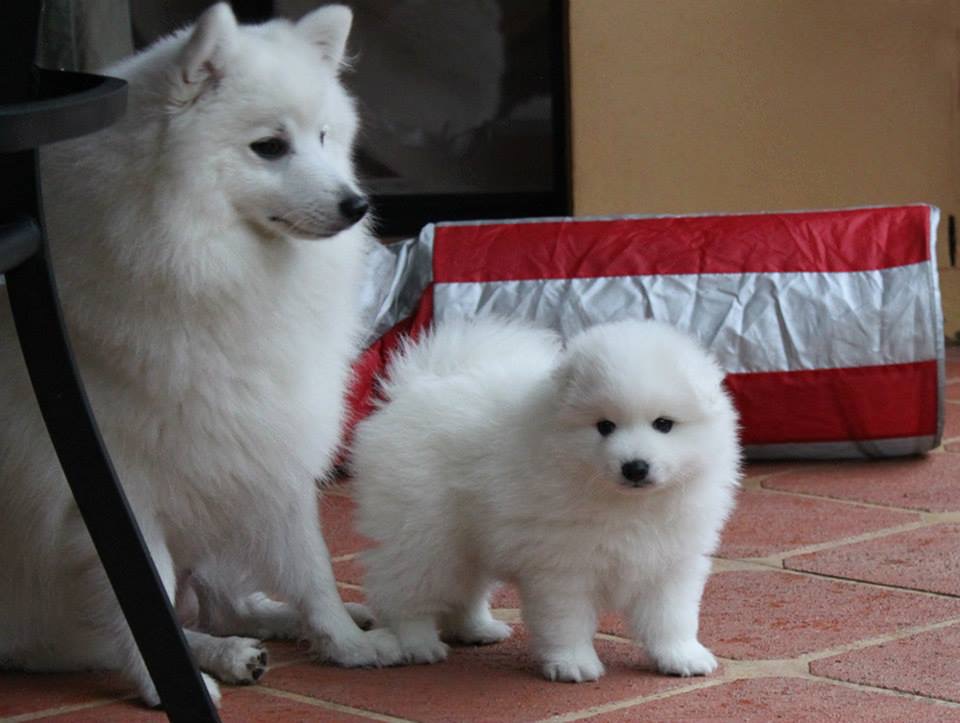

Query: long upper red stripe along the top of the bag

[434,206,930,283]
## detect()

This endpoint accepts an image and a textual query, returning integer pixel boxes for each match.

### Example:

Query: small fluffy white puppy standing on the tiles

[353,319,740,682]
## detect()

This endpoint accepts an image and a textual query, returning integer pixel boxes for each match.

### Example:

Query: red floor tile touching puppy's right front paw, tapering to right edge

[688,571,960,660]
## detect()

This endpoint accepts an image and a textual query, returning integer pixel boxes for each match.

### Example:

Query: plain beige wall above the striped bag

[570,0,960,340]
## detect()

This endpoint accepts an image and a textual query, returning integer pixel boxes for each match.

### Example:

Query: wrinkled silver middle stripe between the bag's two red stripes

[434,262,939,373]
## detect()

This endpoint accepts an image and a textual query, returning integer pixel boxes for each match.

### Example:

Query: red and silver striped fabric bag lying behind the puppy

[353,205,944,459]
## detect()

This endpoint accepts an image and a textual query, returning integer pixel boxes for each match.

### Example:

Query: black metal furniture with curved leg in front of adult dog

[0,0,219,722]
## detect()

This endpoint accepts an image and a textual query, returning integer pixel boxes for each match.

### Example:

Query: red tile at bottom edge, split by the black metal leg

[34,687,370,723]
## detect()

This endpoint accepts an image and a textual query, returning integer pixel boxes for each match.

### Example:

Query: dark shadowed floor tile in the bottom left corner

[0,672,133,716]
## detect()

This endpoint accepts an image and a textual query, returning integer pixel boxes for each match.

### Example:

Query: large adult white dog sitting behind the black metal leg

[0,4,398,704]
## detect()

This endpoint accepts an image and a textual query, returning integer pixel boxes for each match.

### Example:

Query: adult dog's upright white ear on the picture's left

[173,2,237,103]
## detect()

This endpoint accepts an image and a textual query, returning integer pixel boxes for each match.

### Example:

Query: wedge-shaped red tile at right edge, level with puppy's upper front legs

[784,524,960,596]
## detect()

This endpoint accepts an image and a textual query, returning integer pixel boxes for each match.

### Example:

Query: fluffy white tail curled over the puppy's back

[381,316,562,399]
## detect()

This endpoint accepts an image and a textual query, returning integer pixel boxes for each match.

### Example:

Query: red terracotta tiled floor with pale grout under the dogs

[0,350,960,723]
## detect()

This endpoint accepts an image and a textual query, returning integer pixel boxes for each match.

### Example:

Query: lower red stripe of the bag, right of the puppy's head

[727,361,938,444]
